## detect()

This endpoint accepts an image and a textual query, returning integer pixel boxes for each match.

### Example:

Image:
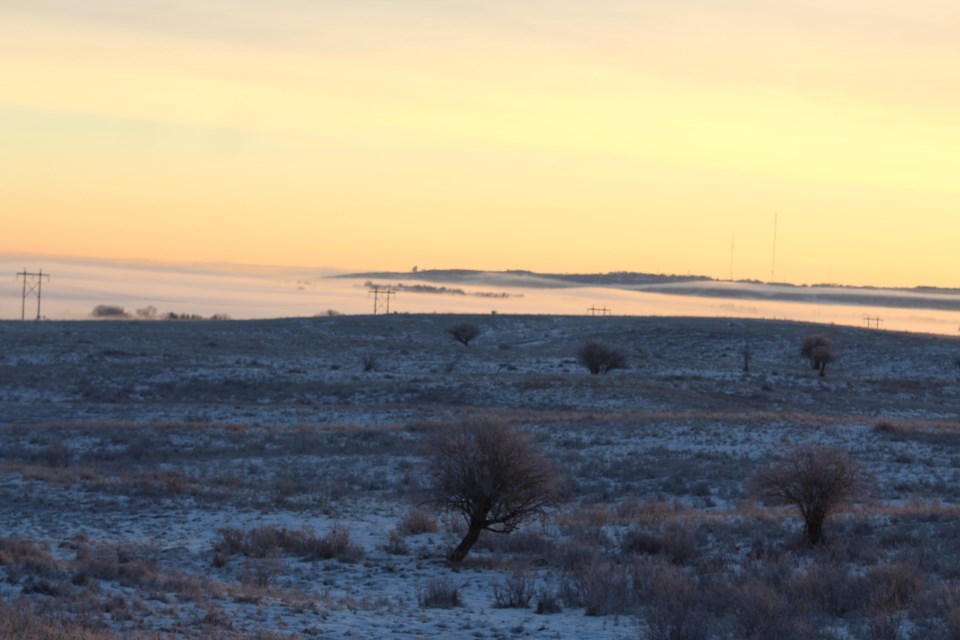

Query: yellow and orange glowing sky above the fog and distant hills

[0,0,960,287]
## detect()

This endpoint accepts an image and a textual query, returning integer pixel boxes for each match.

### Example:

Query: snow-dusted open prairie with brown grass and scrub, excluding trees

[0,314,960,640]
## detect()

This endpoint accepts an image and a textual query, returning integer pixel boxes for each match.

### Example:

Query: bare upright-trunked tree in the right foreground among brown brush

[750,445,866,546]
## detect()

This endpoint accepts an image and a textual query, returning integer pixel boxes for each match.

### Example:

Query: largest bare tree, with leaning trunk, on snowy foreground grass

[426,420,562,562]
